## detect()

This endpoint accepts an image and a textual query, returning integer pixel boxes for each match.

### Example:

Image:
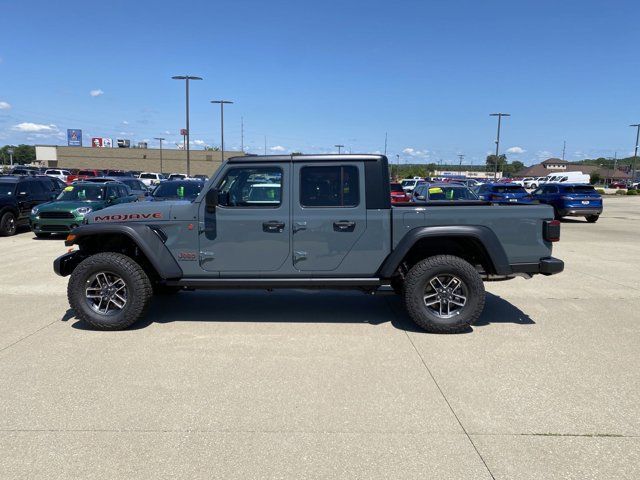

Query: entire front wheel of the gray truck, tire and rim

[67,252,153,330]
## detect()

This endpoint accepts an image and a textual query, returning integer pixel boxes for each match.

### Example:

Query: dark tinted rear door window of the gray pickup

[300,165,360,207]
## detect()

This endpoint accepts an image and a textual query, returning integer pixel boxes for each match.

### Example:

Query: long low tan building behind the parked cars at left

[36,145,243,176]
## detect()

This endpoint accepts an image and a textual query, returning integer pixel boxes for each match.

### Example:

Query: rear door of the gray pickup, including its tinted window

[292,163,367,274]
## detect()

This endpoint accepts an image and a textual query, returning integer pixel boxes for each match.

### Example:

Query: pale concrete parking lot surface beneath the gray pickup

[0,197,640,479]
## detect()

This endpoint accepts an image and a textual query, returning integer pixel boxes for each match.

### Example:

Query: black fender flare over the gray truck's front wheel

[65,223,183,280]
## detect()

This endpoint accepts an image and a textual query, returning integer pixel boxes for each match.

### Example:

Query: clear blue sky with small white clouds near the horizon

[0,0,640,165]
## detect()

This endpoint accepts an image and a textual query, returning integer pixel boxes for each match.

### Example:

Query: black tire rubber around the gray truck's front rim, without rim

[67,252,153,330]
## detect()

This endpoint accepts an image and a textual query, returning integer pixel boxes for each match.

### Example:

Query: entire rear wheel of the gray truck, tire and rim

[404,255,485,333]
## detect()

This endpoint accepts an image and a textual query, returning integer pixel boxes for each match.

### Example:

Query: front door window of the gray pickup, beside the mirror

[218,167,282,207]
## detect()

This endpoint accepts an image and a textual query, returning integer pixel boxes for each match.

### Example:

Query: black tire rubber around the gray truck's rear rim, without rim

[404,255,485,333]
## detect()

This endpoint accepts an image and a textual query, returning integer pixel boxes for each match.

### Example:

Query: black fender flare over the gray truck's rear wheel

[378,225,513,278]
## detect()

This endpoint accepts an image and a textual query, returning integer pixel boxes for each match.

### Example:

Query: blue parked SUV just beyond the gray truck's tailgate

[533,183,602,223]
